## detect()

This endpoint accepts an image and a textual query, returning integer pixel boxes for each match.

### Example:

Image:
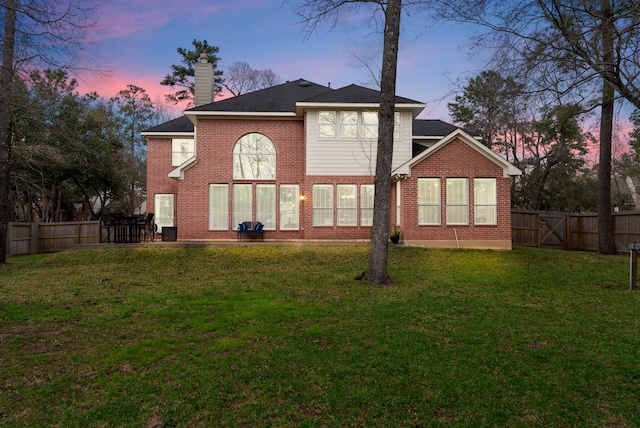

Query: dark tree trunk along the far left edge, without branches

[0,0,16,264]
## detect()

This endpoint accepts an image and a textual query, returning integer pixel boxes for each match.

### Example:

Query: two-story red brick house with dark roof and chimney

[143,58,520,249]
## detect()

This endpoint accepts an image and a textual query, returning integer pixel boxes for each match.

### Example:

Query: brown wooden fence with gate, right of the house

[511,210,640,253]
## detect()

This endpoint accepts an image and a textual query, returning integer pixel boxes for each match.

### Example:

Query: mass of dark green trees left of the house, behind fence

[11,70,168,221]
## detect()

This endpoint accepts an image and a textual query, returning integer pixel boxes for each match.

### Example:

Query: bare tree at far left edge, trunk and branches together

[0,0,95,264]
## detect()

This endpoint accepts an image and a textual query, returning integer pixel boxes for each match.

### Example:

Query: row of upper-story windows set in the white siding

[318,111,400,139]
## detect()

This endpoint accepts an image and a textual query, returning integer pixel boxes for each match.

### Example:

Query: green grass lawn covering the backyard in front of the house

[0,246,640,428]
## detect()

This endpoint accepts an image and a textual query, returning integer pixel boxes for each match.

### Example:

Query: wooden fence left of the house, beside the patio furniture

[7,221,100,256]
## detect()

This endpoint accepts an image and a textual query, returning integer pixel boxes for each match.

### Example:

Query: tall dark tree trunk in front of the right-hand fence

[598,0,617,254]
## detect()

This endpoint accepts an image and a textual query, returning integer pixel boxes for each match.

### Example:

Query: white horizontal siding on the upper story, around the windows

[306,110,412,176]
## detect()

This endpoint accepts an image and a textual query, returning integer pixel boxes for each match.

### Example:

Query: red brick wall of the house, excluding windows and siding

[147,119,511,246]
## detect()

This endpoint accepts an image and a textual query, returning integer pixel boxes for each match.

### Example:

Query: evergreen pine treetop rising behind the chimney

[160,39,224,104]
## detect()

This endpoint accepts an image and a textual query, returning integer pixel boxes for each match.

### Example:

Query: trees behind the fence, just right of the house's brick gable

[449,71,596,212]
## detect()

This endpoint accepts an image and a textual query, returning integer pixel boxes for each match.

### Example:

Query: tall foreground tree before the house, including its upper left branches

[298,0,402,285]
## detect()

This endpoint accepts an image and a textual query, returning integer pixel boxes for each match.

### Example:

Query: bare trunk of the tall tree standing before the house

[367,0,402,285]
